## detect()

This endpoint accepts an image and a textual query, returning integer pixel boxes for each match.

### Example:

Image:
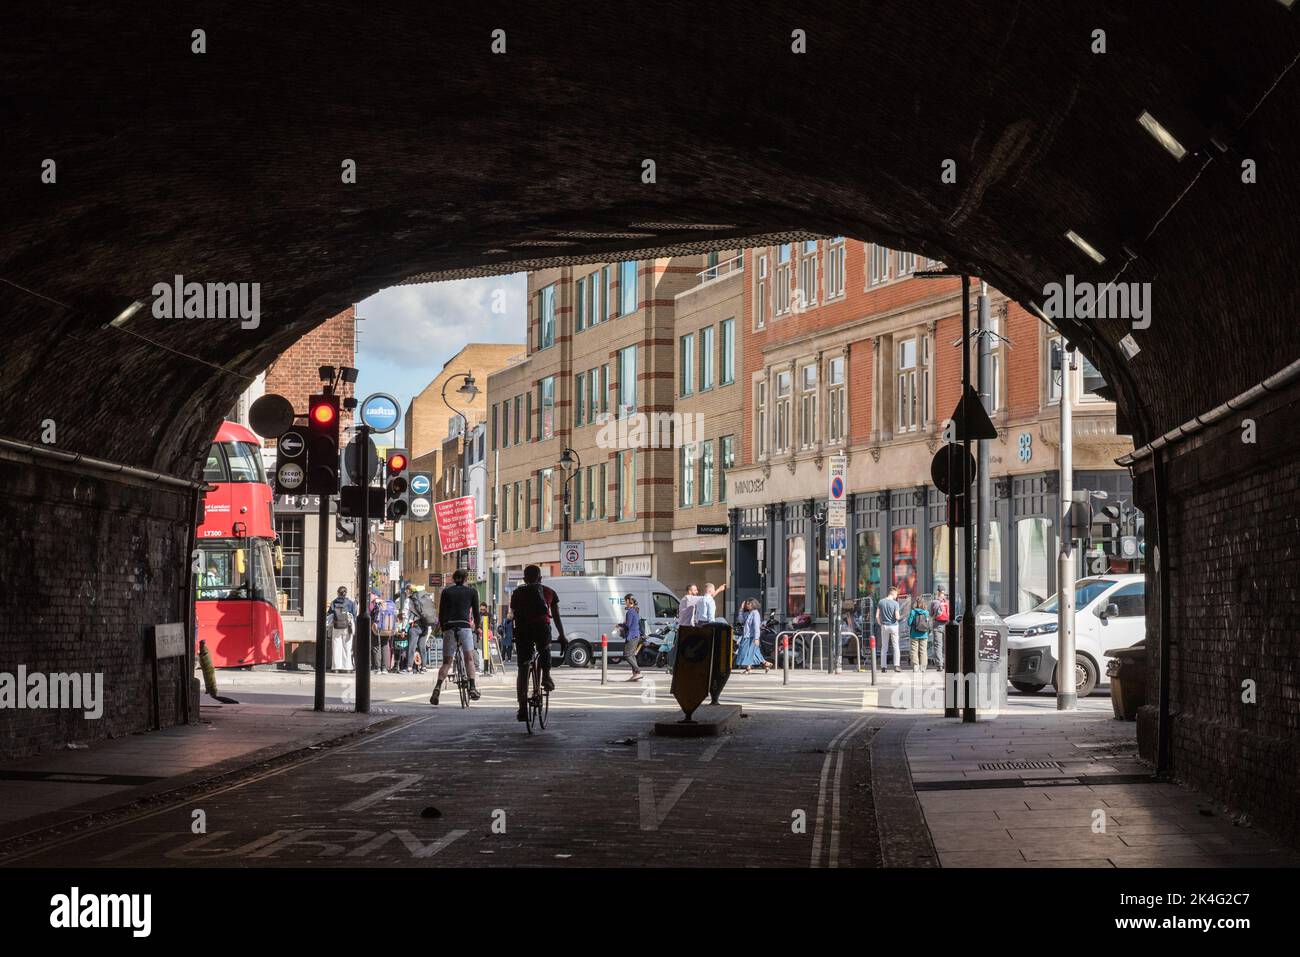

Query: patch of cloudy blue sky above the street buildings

[356,273,528,418]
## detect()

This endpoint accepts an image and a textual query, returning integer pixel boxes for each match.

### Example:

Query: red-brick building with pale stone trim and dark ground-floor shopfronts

[728,243,1132,620]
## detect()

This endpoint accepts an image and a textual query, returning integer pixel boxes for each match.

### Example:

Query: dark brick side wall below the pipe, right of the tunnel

[1136,391,1300,846]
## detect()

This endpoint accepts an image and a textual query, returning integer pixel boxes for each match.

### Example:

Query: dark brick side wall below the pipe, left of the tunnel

[0,459,198,758]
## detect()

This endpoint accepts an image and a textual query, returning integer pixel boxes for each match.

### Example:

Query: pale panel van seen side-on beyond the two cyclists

[506,575,677,668]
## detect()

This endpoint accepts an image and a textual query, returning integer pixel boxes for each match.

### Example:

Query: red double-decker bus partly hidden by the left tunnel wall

[195,421,285,668]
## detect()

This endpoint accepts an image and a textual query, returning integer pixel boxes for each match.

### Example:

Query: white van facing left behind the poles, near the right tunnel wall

[1006,575,1147,698]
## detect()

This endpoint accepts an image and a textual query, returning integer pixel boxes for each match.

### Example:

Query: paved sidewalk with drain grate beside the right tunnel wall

[906,712,1300,867]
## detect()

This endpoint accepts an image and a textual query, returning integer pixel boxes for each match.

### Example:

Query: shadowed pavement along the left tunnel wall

[0,701,394,843]
